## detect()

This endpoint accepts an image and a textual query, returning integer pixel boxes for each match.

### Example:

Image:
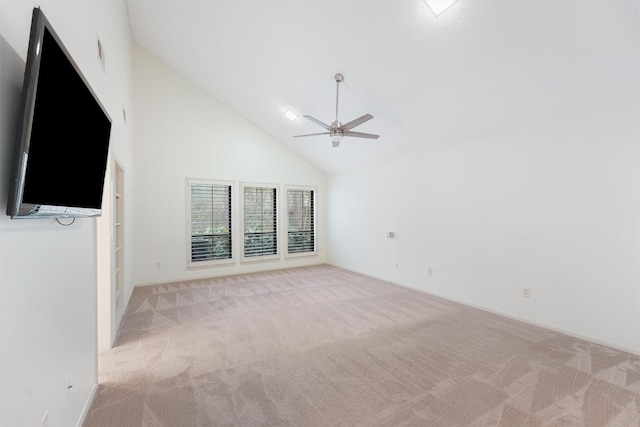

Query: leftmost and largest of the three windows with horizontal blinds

[189,180,232,264]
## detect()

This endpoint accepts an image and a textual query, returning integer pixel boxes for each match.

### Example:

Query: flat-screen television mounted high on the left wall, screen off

[7,8,111,218]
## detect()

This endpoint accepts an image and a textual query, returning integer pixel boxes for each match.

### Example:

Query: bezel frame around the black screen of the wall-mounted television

[6,7,112,219]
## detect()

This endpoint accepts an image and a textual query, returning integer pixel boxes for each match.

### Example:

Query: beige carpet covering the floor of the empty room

[84,266,640,427]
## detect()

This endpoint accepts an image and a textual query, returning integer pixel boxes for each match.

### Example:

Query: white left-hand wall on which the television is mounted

[0,0,132,427]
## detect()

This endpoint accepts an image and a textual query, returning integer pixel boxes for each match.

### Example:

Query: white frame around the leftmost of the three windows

[185,178,237,268]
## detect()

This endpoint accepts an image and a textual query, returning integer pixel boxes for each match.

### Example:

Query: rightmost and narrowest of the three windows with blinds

[287,188,316,254]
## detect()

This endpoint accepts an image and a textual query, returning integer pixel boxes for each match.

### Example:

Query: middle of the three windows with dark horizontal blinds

[242,185,278,258]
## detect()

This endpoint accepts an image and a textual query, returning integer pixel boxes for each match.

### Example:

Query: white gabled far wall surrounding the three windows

[134,48,326,284]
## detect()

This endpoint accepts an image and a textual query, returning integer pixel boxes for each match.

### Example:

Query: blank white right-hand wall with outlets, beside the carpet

[328,98,640,353]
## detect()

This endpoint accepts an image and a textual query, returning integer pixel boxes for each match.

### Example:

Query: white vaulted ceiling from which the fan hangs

[127,0,640,173]
